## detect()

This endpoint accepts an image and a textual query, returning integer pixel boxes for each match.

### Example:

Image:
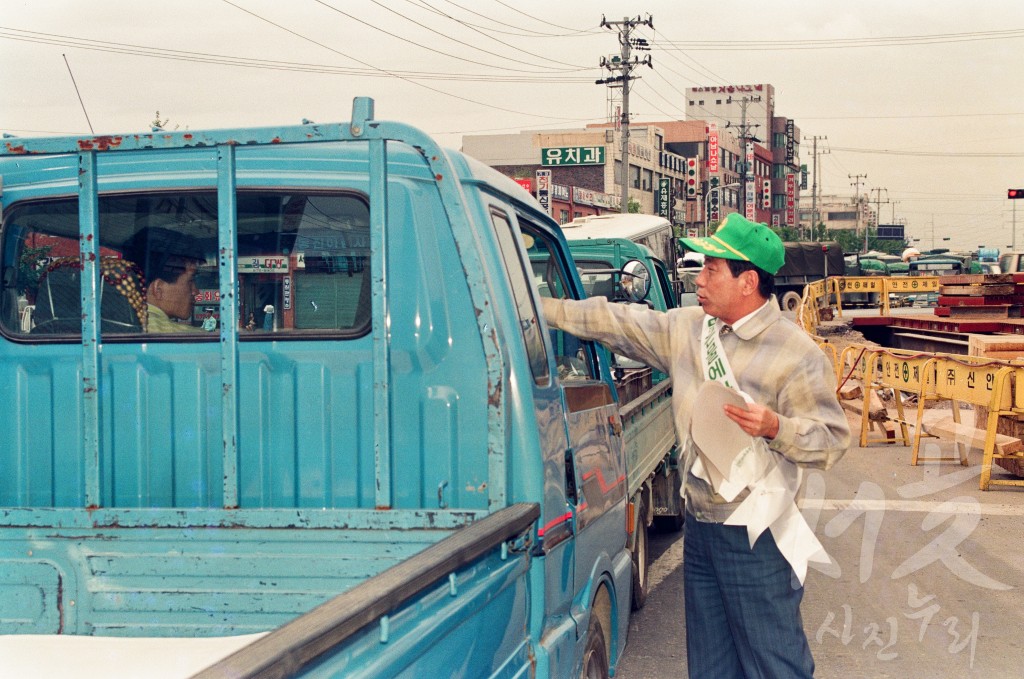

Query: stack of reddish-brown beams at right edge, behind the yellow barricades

[935,273,1024,319]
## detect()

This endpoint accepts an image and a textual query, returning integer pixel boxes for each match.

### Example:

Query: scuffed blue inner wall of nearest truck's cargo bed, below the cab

[0,510,466,636]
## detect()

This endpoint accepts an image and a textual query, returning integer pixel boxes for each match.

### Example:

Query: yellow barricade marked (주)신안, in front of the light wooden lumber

[910,354,1014,477]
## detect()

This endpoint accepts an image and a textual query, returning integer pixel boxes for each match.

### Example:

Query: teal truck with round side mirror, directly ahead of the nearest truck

[542,213,684,609]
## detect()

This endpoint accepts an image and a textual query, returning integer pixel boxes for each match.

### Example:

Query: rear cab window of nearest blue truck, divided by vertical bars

[0,190,371,341]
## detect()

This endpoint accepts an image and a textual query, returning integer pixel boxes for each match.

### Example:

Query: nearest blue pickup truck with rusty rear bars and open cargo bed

[0,98,663,677]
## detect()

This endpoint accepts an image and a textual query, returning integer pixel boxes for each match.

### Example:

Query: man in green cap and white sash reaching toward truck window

[542,214,850,679]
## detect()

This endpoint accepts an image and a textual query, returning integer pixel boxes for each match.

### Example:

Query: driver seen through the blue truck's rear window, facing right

[123,226,206,333]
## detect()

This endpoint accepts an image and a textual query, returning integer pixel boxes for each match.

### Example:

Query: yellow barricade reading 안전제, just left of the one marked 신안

[860,349,935,448]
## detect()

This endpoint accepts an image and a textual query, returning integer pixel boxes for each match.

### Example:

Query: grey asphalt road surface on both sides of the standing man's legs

[615,409,1024,679]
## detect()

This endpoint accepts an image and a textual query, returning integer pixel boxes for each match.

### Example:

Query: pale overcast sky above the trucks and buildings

[0,0,1024,249]
